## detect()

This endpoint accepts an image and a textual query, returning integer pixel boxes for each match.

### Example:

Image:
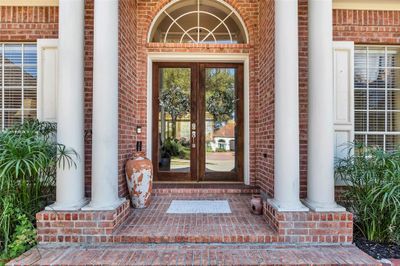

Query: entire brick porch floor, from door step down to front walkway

[9,184,379,265]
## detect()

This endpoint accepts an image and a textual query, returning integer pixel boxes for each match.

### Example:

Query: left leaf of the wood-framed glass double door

[153,63,195,181]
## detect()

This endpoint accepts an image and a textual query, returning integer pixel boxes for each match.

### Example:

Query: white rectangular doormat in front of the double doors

[167,200,232,214]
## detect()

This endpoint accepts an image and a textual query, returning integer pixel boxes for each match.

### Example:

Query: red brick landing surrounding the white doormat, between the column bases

[113,194,277,243]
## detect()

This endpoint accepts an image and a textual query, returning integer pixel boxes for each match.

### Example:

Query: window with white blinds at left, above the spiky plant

[0,43,37,130]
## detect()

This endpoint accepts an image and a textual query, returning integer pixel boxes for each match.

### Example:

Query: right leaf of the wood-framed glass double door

[200,64,243,181]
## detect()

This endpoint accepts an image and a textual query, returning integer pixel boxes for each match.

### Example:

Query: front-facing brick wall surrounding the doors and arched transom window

[136,0,259,191]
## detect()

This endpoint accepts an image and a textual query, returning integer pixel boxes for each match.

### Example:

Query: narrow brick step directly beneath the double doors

[153,183,260,196]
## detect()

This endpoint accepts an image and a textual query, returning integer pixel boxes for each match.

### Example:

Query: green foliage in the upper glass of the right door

[206,69,236,125]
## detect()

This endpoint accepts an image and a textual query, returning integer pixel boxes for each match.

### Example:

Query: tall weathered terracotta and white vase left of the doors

[125,156,153,209]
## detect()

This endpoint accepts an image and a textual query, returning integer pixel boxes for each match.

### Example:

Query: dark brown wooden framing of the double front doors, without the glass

[151,62,244,182]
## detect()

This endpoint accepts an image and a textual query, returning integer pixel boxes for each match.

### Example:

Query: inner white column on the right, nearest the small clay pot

[270,0,308,211]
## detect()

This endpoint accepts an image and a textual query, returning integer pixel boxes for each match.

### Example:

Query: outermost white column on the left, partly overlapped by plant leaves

[47,0,86,210]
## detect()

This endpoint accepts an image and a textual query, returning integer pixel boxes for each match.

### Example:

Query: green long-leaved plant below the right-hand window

[336,144,400,243]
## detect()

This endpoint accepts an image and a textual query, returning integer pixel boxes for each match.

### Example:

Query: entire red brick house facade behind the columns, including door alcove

[0,0,400,203]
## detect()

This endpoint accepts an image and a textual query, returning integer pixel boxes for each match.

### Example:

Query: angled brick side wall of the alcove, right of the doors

[256,0,275,196]
